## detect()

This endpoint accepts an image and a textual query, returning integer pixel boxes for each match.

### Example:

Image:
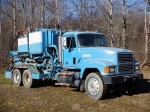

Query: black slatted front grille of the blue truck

[118,54,134,72]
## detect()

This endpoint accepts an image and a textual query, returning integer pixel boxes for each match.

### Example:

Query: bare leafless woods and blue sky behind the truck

[0,0,150,70]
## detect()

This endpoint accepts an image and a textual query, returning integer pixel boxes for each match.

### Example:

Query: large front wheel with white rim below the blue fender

[85,73,107,100]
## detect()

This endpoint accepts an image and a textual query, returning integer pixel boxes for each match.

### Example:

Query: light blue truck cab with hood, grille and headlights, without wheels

[62,32,140,78]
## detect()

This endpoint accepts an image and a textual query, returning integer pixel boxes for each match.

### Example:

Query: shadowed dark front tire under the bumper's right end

[123,79,137,95]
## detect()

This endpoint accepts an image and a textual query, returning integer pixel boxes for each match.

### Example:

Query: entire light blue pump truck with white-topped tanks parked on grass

[5,28,143,100]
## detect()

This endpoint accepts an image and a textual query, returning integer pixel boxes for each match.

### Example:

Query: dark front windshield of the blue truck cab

[78,34,107,47]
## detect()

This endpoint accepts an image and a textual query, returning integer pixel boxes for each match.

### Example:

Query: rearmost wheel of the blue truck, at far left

[12,69,22,86]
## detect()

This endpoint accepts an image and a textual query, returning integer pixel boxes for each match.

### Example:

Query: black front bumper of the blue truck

[102,73,143,84]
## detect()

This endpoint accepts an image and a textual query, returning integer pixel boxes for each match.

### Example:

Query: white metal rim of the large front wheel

[88,78,99,95]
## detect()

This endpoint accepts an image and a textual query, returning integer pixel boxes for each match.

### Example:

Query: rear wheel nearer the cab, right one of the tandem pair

[22,70,34,88]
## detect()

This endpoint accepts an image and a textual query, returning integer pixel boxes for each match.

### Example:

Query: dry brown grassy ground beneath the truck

[0,66,150,112]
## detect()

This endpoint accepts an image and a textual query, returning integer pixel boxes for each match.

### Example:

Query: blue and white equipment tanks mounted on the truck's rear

[18,29,59,55]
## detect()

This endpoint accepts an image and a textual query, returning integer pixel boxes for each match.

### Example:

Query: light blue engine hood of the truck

[78,47,132,65]
